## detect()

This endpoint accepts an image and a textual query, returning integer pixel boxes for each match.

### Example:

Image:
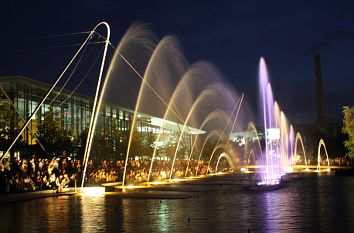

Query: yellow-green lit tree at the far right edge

[342,106,354,158]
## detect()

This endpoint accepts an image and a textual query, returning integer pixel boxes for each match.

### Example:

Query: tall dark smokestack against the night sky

[315,54,326,130]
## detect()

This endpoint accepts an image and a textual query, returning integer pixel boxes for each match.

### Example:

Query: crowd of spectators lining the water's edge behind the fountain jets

[0,156,217,193]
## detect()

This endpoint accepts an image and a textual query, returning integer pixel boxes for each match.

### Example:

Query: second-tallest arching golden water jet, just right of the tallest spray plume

[121,34,186,187]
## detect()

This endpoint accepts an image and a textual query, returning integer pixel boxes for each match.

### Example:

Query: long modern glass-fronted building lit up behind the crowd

[0,76,205,159]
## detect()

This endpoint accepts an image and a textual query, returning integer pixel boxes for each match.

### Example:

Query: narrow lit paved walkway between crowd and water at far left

[0,188,75,204]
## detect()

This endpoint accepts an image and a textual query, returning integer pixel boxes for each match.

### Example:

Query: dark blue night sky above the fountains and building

[0,0,354,123]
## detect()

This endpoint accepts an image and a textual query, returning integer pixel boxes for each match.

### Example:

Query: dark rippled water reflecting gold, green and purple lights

[0,175,354,233]
